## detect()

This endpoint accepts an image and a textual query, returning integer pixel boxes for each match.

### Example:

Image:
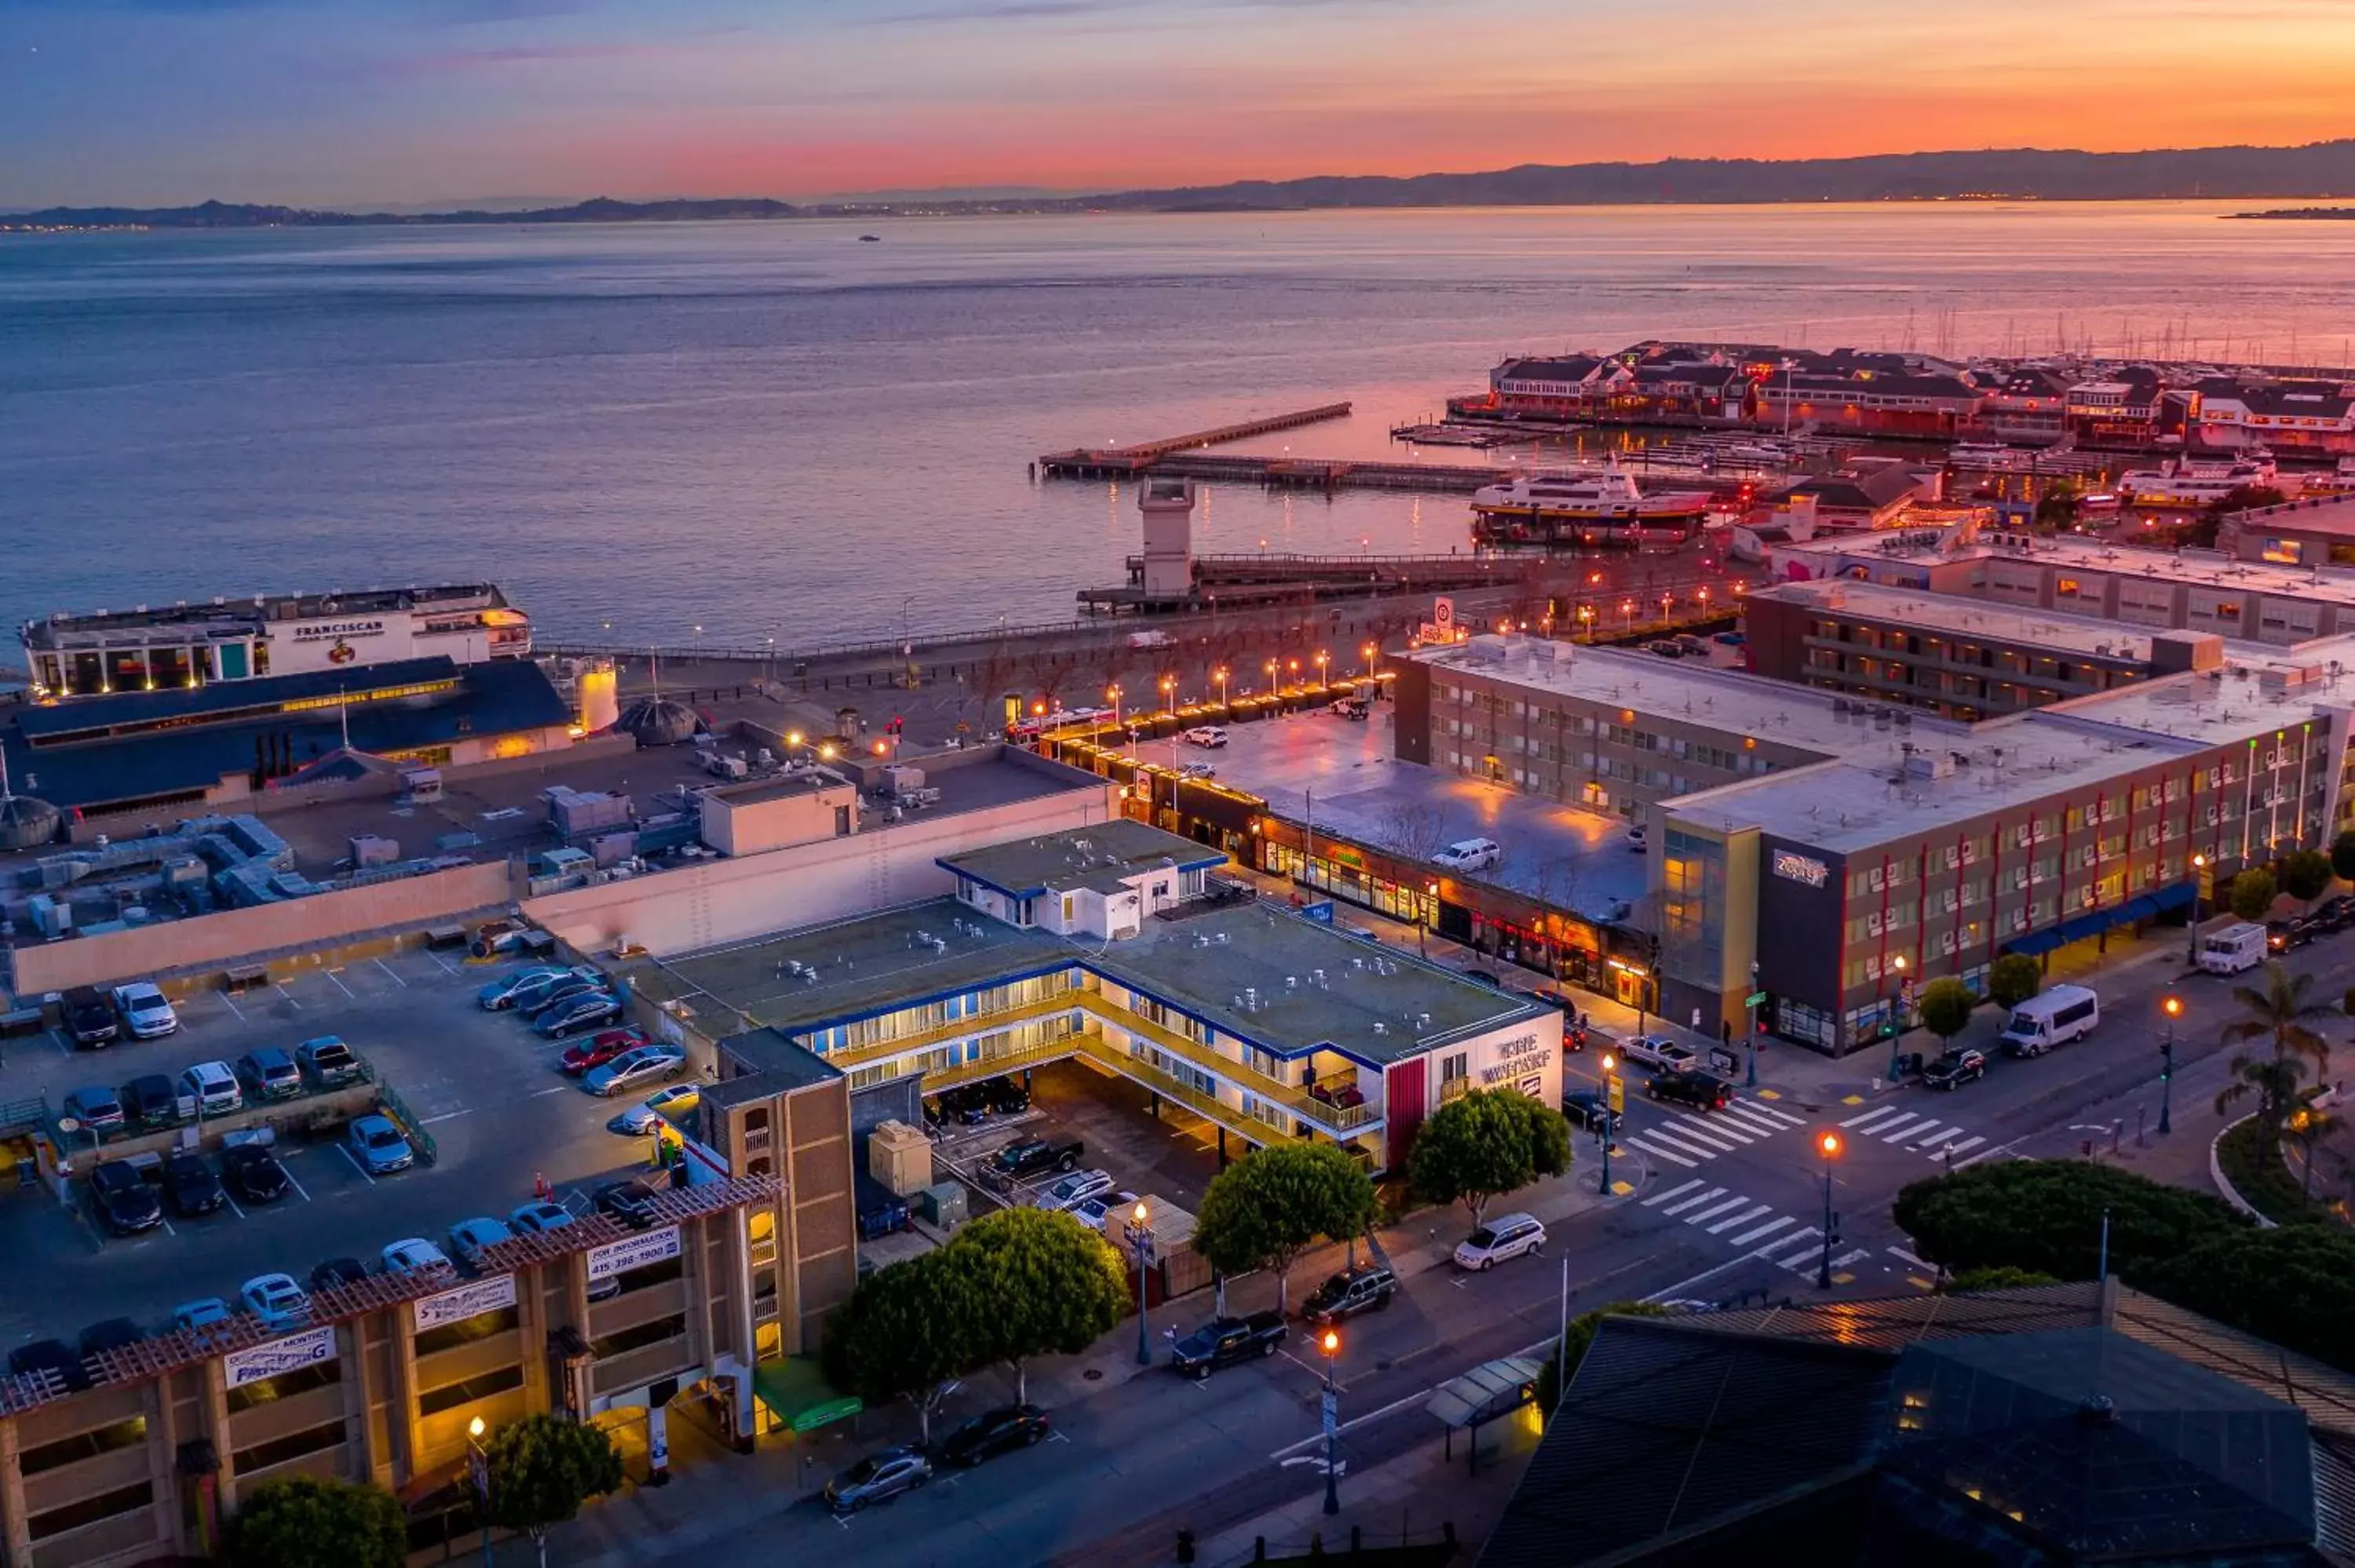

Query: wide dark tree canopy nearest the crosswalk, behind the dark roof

[1891,1161,2249,1278]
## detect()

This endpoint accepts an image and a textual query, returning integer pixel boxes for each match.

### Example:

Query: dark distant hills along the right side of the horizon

[1060,141,2355,212]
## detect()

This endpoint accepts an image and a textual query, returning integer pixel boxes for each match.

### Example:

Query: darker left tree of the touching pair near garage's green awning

[820,1241,991,1441]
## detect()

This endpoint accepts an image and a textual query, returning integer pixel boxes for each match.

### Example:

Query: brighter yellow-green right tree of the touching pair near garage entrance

[961,1208,1128,1403]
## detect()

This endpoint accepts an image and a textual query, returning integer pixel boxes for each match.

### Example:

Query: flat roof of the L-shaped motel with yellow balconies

[633,899,1545,1071]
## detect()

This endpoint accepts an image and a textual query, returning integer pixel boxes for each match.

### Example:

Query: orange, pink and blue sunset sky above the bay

[0,0,2355,207]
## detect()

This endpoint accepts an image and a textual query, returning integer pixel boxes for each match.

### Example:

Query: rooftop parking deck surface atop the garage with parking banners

[0,932,683,1347]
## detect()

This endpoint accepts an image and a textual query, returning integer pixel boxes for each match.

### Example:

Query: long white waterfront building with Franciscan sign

[24,582,532,697]
